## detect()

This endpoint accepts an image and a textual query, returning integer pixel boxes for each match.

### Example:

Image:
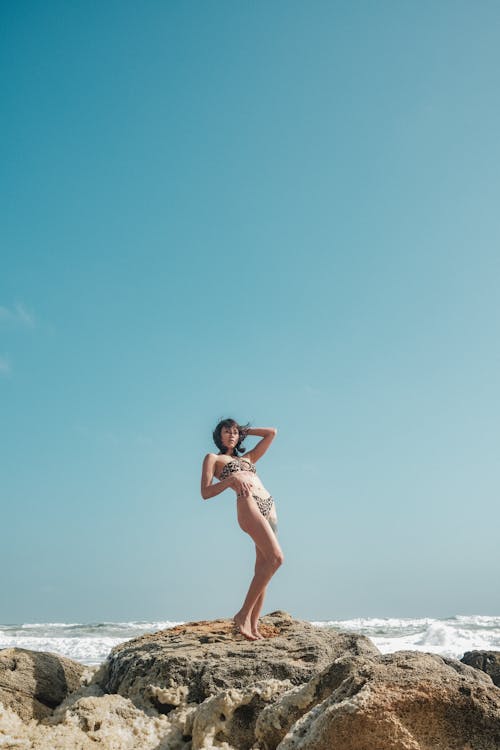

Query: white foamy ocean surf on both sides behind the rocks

[0,615,500,666]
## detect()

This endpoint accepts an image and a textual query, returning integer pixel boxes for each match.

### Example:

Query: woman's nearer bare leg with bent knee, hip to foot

[233,496,283,641]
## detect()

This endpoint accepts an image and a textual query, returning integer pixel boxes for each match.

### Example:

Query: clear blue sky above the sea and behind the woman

[0,0,500,623]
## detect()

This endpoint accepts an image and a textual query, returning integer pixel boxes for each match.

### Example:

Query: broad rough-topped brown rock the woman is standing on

[95,612,379,714]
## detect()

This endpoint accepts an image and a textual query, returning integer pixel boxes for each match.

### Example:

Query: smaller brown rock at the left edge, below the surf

[0,648,88,720]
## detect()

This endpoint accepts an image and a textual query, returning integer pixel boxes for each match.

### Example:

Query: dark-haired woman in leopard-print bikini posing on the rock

[201,419,283,641]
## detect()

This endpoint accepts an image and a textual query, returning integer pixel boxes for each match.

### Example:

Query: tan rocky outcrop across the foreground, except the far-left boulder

[0,612,500,750]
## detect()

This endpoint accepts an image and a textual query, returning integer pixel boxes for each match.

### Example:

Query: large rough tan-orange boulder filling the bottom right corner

[276,651,500,750]
